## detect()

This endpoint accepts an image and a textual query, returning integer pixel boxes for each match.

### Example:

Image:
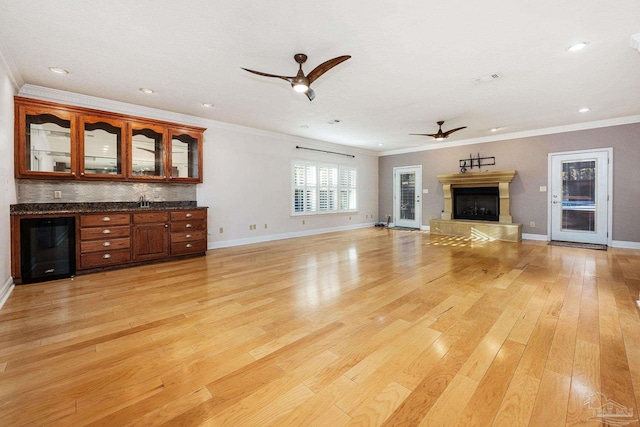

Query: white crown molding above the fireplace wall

[378,115,640,157]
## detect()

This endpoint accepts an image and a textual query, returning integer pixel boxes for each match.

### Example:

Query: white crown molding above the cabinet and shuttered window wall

[18,84,378,157]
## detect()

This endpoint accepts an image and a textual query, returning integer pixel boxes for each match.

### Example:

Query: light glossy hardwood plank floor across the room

[0,227,640,427]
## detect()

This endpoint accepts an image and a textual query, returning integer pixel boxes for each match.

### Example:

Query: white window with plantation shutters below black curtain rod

[292,160,357,215]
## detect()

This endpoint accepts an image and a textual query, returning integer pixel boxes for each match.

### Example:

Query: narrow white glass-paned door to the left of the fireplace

[393,166,422,228]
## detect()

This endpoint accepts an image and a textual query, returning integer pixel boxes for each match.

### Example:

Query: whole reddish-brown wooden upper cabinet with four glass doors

[15,97,205,183]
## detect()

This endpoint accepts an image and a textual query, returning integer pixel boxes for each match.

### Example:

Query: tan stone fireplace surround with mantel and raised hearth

[429,170,522,242]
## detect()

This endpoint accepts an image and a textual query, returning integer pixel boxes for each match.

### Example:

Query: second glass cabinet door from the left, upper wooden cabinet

[80,116,125,178]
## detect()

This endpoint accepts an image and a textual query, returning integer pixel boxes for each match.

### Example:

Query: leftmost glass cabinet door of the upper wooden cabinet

[18,107,76,177]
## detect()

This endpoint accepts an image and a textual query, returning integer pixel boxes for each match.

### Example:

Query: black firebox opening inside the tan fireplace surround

[453,187,500,221]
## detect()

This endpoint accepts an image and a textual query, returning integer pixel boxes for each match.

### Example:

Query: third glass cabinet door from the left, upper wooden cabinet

[129,123,167,179]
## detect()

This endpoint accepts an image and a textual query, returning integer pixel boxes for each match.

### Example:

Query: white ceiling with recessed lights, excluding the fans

[0,0,640,151]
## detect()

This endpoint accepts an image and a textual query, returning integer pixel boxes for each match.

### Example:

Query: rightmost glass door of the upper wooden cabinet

[169,129,202,182]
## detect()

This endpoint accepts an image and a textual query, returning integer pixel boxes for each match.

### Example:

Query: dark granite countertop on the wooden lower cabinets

[9,201,204,215]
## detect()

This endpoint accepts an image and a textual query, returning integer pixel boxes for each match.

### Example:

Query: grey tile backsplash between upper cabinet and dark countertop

[16,179,196,203]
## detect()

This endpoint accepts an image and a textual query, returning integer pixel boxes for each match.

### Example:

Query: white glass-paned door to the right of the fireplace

[550,151,609,245]
